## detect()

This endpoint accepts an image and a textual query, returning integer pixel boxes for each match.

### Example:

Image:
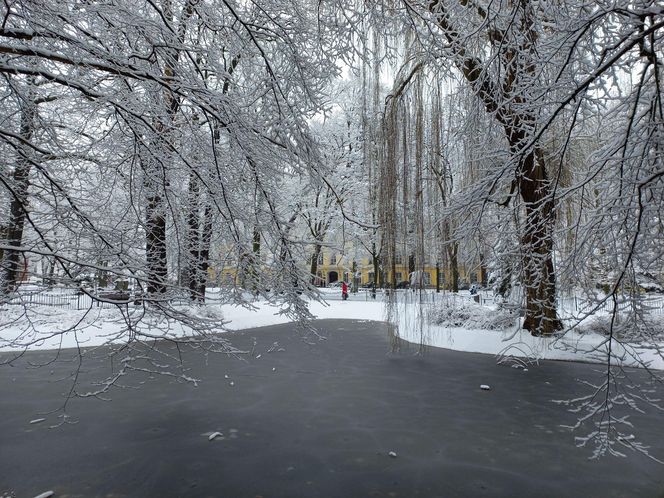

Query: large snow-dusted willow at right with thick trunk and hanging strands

[370,0,659,335]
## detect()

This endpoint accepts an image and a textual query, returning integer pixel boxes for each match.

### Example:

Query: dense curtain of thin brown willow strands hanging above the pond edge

[378,25,444,349]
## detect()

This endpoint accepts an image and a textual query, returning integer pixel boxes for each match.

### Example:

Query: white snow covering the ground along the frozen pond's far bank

[0,291,664,370]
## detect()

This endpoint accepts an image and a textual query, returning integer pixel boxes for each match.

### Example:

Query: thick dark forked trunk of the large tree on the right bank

[429,0,562,335]
